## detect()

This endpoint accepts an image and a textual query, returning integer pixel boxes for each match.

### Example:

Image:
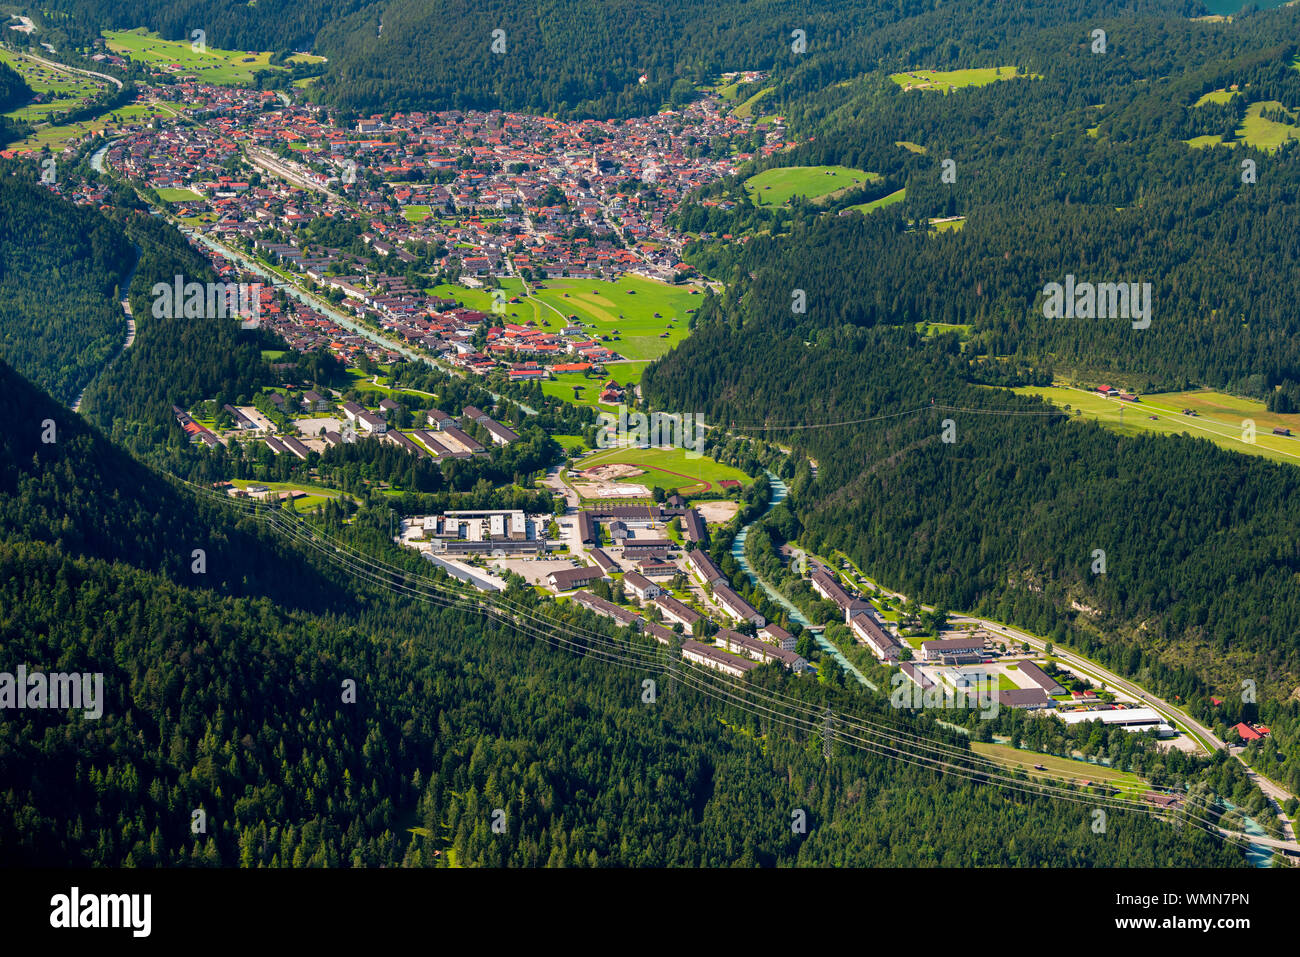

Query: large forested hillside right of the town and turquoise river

[642,0,1300,787]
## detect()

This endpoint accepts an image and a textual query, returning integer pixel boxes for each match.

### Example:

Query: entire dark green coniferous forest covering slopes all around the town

[0,0,1300,867]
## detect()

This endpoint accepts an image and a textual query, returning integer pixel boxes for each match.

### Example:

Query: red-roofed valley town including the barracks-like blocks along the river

[2,27,1269,780]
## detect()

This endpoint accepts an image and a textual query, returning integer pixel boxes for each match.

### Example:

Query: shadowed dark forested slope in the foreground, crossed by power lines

[0,365,1240,866]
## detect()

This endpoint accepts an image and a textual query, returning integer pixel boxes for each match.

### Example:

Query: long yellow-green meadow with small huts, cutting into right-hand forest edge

[1014,386,1300,464]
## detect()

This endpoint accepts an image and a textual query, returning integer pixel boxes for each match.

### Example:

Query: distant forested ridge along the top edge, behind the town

[38,0,1203,116]
